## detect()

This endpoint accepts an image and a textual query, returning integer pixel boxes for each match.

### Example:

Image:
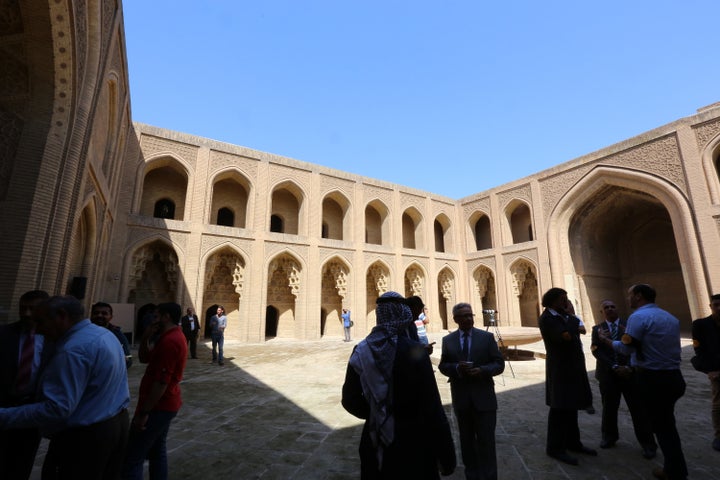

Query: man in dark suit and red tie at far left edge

[0,290,50,480]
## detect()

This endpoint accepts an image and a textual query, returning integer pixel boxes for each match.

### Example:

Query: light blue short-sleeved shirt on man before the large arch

[625,303,681,370]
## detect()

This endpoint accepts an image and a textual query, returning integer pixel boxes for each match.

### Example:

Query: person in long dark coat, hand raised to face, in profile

[538,287,597,465]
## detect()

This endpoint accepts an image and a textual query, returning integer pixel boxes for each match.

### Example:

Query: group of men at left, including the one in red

[0,290,191,480]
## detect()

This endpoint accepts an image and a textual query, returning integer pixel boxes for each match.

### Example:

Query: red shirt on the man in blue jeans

[136,327,187,412]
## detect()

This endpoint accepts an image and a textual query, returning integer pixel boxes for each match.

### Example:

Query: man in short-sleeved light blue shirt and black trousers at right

[606,284,688,480]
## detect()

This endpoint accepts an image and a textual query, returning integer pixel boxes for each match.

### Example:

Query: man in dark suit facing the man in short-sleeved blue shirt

[590,300,657,459]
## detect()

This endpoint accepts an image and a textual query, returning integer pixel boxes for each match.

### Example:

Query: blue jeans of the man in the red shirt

[122,412,177,480]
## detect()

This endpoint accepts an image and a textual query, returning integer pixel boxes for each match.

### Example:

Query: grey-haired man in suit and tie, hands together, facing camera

[439,303,505,480]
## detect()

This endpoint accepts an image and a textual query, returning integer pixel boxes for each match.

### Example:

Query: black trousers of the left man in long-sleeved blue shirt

[42,410,130,480]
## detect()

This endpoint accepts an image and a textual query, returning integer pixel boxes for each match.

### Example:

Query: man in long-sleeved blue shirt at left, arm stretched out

[0,296,130,478]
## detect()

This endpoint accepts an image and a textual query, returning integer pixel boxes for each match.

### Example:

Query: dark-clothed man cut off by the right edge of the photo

[692,294,720,451]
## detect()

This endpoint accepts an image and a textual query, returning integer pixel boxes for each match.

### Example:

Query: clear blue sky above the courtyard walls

[123,0,720,199]
